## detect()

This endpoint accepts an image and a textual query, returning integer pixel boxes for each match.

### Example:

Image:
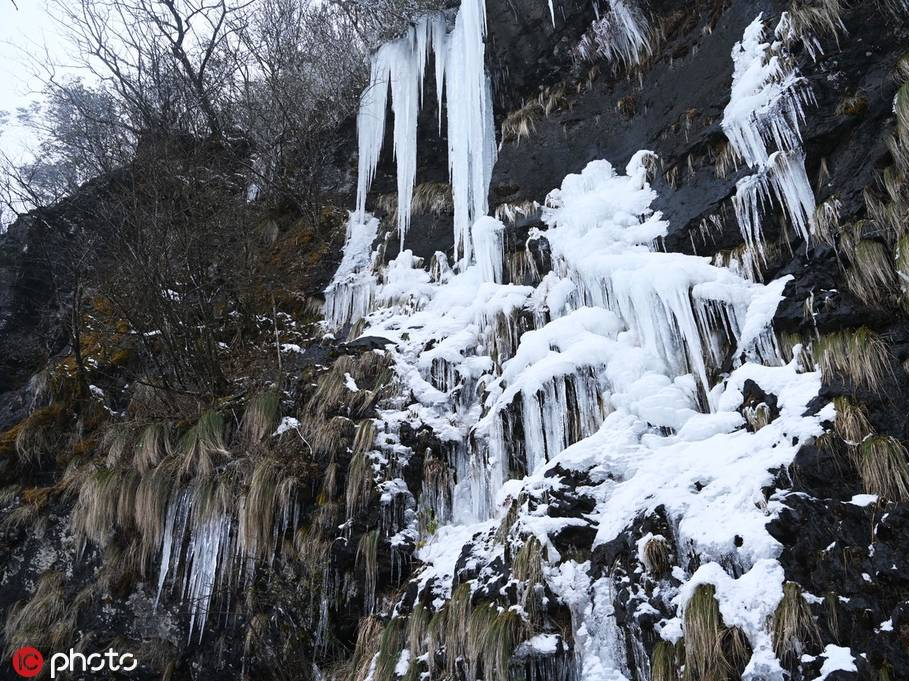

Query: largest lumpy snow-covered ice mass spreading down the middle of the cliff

[328,139,830,680]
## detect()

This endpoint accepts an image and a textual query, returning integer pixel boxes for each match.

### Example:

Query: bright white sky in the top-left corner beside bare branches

[0,0,71,158]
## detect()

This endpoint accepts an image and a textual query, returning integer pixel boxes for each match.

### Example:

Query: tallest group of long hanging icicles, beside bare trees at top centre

[357,0,496,260]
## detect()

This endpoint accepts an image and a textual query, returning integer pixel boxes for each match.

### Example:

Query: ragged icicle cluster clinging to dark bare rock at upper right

[723,14,815,268]
